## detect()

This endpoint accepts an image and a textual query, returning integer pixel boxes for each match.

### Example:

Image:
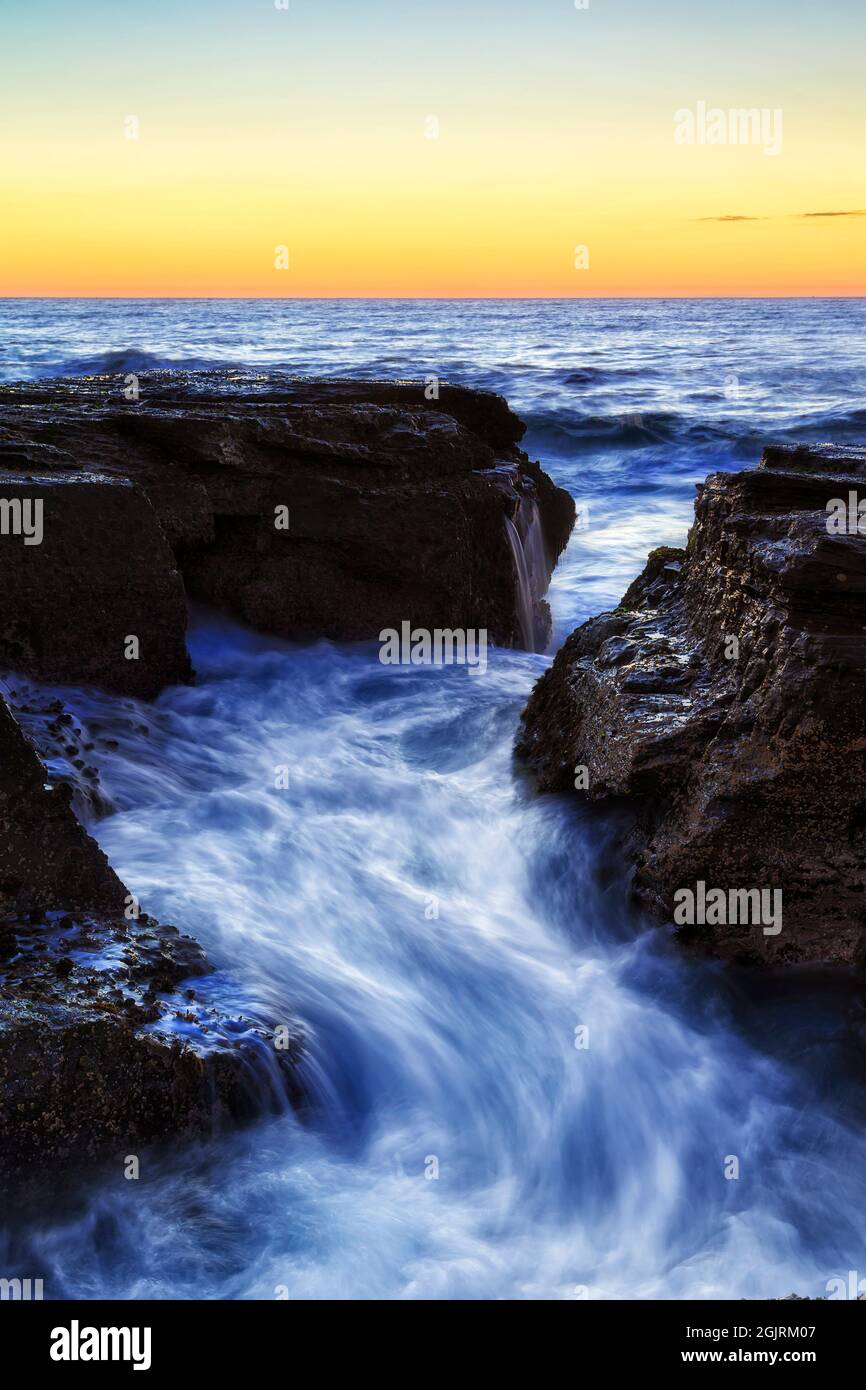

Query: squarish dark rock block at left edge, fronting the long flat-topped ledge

[0,471,192,699]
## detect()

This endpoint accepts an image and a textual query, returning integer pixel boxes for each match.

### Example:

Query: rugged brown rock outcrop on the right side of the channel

[520,445,866,963]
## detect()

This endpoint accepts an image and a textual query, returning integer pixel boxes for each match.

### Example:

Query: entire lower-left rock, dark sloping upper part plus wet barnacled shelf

[0,699,300,1187]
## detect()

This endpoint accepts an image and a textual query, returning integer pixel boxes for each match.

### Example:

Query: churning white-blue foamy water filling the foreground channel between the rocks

[1,619,866,1298]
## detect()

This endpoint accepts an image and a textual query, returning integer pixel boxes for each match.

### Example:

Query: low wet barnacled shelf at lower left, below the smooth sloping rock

[0,915,302,1187]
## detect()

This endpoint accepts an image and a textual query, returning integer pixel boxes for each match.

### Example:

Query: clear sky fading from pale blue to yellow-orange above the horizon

[0,0,866,297]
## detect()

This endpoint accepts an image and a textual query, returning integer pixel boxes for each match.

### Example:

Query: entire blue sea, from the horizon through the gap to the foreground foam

[0,299,866,1298]
